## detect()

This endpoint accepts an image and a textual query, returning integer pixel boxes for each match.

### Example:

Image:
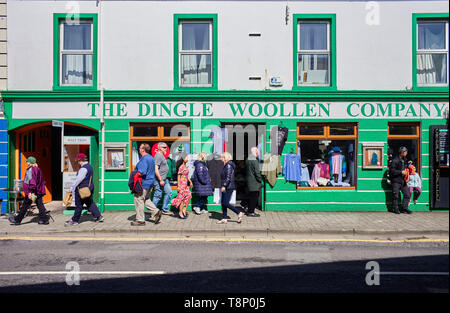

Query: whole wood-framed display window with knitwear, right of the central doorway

[297,123,358,189]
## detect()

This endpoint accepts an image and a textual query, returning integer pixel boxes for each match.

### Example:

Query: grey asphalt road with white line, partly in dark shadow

[0,240,449,294]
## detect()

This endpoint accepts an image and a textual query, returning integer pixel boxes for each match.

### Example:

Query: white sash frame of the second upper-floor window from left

[178,20,214,87]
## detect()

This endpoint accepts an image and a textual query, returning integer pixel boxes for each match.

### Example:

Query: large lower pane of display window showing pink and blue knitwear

[299,140,356,188]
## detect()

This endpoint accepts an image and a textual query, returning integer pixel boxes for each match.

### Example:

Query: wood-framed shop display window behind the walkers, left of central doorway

[130,123,191,186]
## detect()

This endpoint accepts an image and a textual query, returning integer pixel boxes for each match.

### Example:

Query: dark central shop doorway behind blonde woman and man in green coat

[221,123,266,210]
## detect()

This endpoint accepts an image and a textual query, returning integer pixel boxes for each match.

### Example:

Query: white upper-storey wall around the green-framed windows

[7,0,448,90]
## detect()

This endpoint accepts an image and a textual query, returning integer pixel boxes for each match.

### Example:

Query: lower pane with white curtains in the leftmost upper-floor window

[61,54,92,85]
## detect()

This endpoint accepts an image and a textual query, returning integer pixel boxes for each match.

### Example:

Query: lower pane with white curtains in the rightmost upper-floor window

[417,53,447,85]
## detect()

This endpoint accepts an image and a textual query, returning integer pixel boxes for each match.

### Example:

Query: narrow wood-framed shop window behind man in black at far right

[388,122,422,174]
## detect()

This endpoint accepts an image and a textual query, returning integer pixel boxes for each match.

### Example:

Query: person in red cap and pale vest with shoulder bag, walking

[64,153,104,226]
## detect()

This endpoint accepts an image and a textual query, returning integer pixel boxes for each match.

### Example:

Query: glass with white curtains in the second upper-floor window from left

[181,23,211,85]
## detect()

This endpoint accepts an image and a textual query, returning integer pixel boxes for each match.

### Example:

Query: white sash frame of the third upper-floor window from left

[296,19,331,87]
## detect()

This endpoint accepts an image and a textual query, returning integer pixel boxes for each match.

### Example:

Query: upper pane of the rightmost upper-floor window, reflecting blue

[417,22,445,50]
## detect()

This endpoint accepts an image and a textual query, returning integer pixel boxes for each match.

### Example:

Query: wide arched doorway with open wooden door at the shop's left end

[11,122,98,203]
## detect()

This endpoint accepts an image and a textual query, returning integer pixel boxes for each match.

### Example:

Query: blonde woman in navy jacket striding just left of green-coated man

[217,152,244,224]
